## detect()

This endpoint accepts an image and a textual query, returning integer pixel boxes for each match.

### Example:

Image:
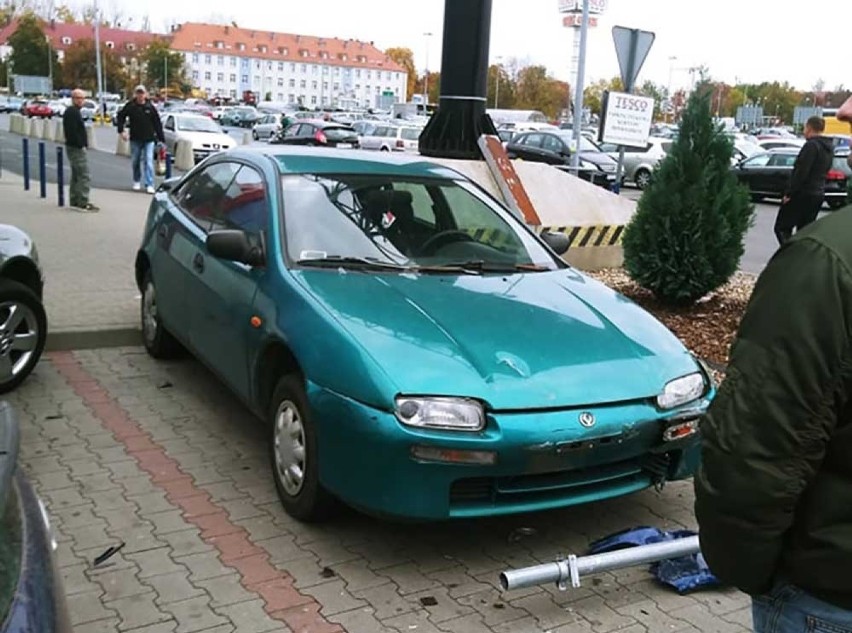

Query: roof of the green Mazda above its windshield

[228,145,465,180]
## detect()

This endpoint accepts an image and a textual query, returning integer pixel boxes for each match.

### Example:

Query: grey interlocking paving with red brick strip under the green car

[9,348,750,633]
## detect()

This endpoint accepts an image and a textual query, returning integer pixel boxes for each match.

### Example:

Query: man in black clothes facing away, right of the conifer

[775,116,834,244]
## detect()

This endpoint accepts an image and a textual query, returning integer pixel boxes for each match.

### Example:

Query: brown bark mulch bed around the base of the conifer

[587,268,756,378]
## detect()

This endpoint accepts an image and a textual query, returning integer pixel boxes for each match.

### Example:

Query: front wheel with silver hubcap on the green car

[269,374,335,523]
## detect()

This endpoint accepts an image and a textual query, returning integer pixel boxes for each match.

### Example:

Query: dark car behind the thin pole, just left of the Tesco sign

[506,129,618,189]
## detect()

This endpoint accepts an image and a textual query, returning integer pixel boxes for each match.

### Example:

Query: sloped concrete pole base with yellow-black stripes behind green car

[427,158,636,270]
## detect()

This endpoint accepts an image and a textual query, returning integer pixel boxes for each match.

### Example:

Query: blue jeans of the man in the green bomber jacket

[751,582,852,633]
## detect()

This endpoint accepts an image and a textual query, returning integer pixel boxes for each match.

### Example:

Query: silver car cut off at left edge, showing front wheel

[0,224,47,393]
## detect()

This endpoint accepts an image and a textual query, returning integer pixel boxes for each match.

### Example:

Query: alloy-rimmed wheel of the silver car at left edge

[0,279,47,393]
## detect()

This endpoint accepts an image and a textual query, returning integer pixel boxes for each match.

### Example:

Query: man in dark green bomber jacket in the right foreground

[695,96,852,633]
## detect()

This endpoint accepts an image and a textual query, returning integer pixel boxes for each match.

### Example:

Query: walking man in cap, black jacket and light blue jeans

[116,86,166,193]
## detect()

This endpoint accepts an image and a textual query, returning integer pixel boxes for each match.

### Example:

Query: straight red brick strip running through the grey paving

[49,352,343,633]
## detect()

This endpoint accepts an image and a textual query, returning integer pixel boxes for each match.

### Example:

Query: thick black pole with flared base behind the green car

[420,0,497,160]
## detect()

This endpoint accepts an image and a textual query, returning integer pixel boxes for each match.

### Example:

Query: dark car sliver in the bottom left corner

[0,400,72,633]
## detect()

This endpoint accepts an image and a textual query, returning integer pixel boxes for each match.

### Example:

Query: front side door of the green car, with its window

[192,161,271,397]
